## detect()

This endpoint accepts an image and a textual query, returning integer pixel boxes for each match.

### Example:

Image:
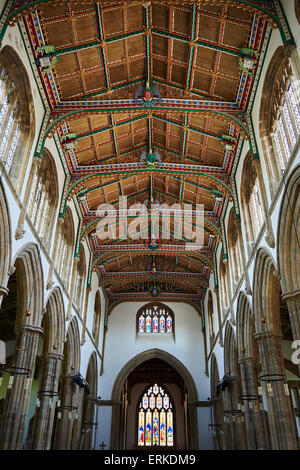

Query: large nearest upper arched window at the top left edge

[0,46,34,192]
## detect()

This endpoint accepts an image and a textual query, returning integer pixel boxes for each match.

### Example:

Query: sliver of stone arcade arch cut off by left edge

[0,182,11,306]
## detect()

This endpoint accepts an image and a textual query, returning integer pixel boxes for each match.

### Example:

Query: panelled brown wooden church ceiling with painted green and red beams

[18,0,276,301]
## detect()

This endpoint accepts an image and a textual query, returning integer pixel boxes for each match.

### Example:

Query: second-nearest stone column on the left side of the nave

[32,353,63,450]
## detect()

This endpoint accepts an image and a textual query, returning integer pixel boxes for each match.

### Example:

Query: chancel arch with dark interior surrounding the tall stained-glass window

[110,349,198,449]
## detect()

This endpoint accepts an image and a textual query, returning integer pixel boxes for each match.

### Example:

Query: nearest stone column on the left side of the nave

[0,325,43,450]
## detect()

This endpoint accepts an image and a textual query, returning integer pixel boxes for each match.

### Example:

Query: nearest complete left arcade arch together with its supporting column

[0,243,44,449]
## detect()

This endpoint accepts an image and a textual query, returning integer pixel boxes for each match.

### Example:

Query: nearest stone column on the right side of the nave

[254,331,298,450]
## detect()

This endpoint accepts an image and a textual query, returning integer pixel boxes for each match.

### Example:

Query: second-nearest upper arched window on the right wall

[241,155,264,248]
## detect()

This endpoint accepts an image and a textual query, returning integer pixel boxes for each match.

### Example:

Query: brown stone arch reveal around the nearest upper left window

[0,45,35,192]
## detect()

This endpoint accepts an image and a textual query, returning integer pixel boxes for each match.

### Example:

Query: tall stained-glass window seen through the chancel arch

[137,383,175,447]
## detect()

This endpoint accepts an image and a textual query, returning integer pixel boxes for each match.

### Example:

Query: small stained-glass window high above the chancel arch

[136,303,175,334]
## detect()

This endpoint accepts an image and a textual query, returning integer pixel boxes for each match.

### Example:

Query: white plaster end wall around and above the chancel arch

[97,302,210,448]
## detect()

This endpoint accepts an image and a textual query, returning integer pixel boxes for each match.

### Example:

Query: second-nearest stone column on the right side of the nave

[239,357,270,450]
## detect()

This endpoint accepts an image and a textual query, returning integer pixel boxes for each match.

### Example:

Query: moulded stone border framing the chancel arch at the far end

[110,348,198,450]
